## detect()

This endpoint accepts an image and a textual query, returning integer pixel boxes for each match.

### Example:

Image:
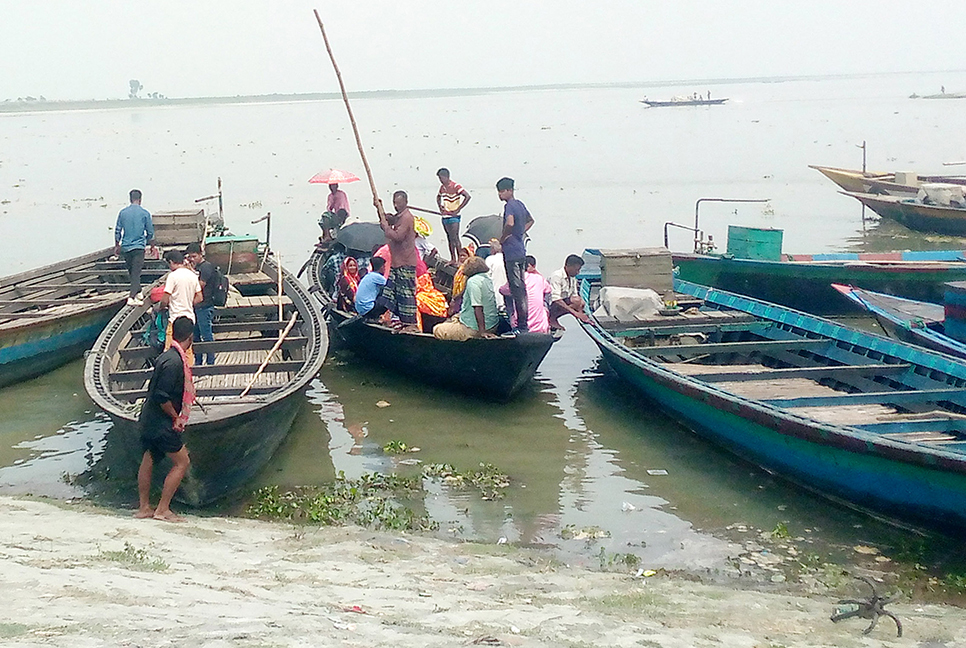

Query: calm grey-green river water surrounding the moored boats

[0,73,966,569]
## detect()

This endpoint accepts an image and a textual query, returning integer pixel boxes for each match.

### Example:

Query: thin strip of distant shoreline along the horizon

[0,70,964,114]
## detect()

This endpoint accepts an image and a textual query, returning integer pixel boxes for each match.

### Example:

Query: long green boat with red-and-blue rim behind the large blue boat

[672,250,966,315]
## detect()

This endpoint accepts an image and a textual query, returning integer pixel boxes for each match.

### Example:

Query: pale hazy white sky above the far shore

[0,0,966,100]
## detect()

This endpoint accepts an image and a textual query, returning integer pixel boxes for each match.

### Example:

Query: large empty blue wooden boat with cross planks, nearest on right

[582,262,966,531]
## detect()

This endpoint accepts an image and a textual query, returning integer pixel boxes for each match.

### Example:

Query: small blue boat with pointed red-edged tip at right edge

[832,284,966,358]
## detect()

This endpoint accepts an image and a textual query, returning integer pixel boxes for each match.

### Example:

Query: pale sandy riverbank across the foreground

[0,497,966,648]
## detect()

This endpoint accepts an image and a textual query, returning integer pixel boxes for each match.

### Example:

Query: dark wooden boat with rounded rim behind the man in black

[84,251,328,506]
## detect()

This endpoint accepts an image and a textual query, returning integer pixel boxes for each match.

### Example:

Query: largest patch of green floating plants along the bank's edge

[247,471,439,531]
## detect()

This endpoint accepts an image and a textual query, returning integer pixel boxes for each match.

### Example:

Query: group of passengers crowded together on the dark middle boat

[327,175,586,341]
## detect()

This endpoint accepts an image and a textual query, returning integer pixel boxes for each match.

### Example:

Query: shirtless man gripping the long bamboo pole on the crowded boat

[377,191,417,328]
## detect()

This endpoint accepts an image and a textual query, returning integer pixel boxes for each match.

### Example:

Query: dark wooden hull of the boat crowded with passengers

[306,250,558,401]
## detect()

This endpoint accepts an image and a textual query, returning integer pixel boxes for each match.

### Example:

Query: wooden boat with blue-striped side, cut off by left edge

[0,248,167,387]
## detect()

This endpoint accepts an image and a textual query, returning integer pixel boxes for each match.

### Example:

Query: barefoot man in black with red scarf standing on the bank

[134,317,194,522]
